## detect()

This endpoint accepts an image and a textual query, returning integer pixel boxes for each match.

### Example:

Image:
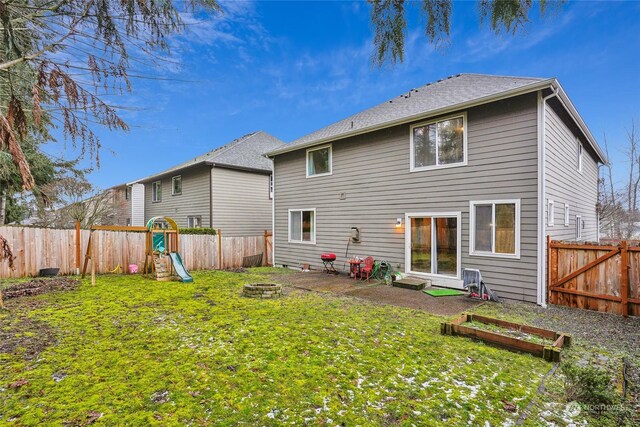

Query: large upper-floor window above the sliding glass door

[410,113,467,171]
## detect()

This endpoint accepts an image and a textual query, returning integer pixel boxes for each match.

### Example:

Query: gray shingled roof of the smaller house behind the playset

[128,130,285,184]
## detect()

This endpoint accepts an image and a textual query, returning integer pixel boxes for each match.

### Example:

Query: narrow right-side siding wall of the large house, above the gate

[545,105,598,241]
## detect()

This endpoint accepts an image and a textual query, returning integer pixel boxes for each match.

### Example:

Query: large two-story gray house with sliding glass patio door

[268,74,605,304]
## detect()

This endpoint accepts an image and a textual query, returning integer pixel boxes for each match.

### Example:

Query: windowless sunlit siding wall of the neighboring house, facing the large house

[211,167,272,236]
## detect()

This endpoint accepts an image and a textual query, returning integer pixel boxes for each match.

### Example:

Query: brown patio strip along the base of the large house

[274,272,482,316]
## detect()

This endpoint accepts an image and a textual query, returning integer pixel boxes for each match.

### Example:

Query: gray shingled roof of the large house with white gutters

[267,74,605,161]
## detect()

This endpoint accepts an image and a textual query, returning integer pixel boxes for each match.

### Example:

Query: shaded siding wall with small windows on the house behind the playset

[144,165,211,227]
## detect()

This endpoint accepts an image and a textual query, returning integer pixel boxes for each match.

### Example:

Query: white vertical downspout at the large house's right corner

[536,85,558,307]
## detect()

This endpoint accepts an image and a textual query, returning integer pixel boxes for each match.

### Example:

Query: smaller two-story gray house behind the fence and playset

[129,131,284,236]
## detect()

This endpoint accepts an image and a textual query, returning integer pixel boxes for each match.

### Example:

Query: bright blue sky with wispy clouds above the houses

[47,1,640,188]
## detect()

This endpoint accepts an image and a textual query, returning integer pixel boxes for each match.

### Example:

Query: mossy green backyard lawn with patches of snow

[0,270,551,426]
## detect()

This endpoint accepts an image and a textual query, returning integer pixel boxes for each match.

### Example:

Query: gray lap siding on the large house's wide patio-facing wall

[274,94,538,302]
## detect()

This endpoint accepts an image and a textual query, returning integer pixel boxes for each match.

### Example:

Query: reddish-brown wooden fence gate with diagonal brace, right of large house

[547,238,640,317]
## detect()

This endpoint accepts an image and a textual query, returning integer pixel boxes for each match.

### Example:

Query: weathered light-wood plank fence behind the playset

[0,226,273,279]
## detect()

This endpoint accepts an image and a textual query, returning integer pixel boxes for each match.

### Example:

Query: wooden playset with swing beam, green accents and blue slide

[82,216,193,283]
